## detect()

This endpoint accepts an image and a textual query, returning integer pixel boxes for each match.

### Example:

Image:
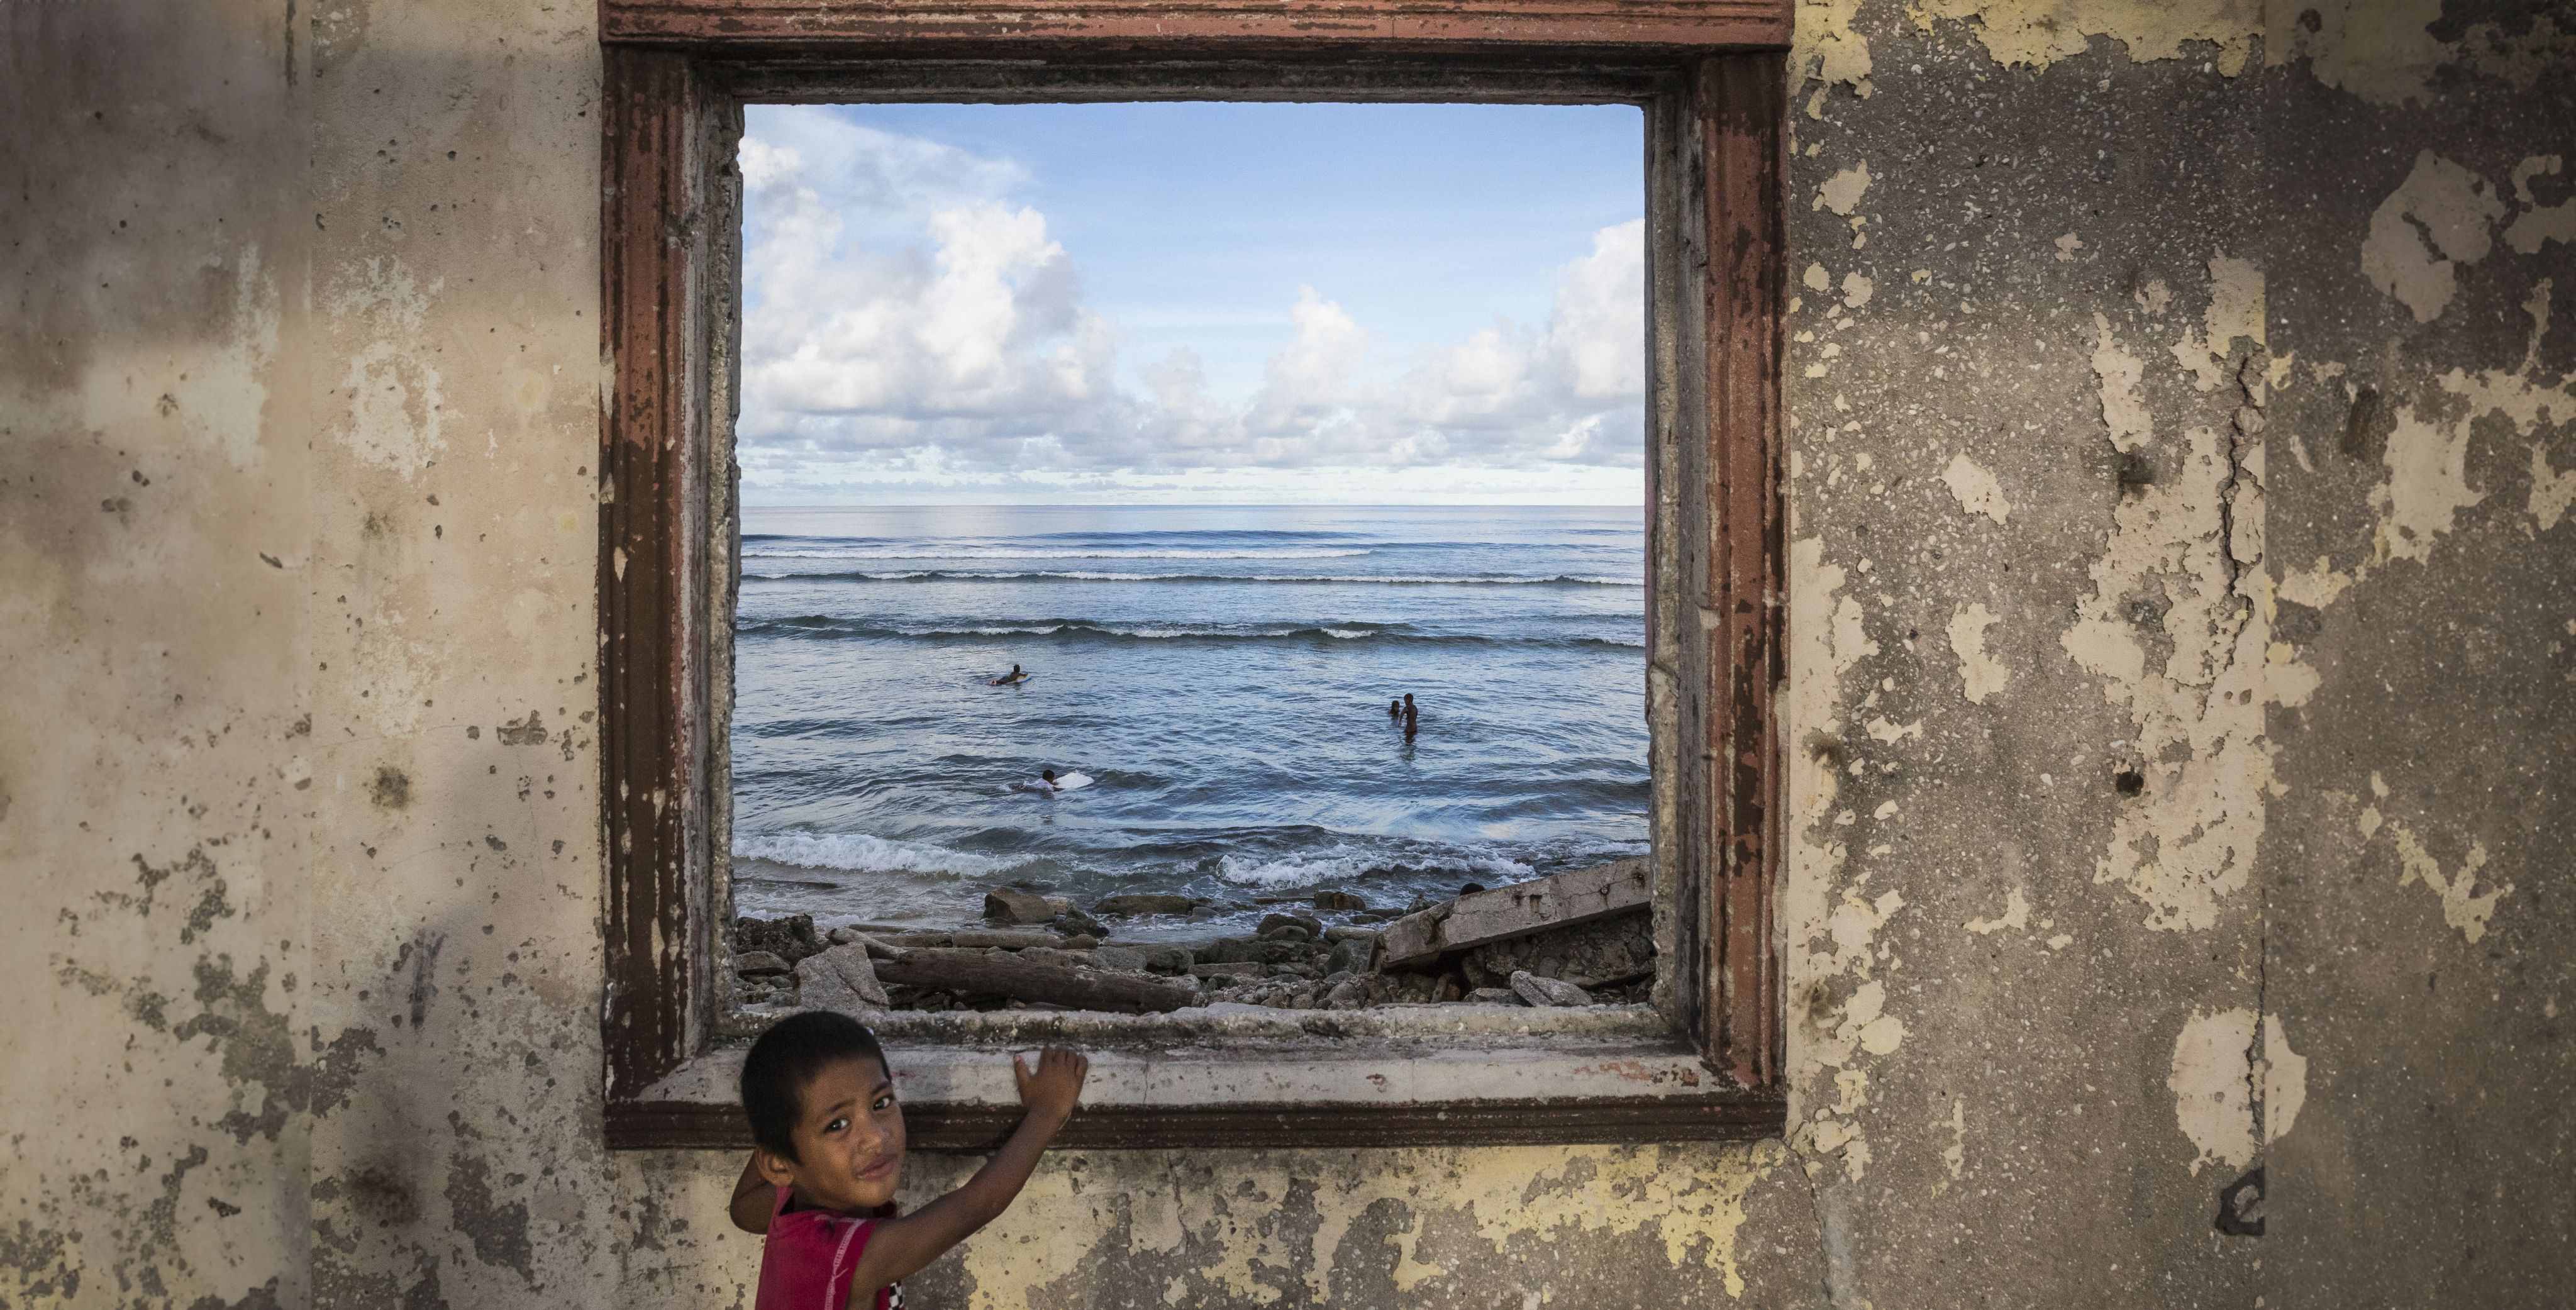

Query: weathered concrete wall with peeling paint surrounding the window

[0,0,2576,1307]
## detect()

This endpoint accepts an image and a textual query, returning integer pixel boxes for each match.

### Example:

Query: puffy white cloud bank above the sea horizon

[740,108,1646,499]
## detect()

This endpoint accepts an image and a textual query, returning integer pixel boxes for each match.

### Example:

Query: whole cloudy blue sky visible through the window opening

[736,103,1646,504]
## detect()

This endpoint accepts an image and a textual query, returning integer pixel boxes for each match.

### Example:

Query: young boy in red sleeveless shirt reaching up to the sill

[731,1011,1090,1310]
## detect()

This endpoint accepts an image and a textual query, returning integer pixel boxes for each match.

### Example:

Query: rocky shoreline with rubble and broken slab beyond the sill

[731,860,1654,1016]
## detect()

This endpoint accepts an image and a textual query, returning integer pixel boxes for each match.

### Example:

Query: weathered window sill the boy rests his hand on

[608,1004,1785,1150]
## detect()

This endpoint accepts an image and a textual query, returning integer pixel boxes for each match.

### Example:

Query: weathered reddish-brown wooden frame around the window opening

[597,0,1790,1148]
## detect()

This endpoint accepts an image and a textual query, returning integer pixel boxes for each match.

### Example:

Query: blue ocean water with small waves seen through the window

[731,507,1646,940]
